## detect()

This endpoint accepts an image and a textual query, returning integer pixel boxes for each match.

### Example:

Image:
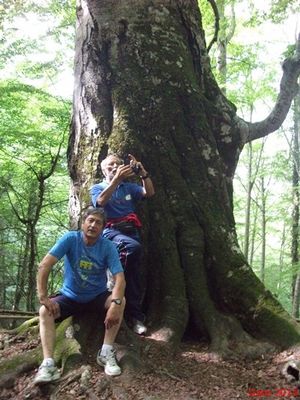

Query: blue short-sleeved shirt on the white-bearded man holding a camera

[90,181,144,218]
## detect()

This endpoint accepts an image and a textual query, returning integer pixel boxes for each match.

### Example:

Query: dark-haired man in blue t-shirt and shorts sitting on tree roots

[34,207,125,385]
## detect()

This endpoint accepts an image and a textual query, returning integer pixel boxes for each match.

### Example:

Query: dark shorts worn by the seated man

[51,291,111,321]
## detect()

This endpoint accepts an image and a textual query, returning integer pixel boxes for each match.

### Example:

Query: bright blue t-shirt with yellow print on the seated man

[49,231,123,303]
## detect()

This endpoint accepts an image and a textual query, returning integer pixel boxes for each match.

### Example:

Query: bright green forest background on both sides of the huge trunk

[0,0,300,317]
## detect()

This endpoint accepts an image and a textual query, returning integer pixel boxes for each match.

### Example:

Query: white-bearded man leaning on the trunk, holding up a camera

[91,154,154,335]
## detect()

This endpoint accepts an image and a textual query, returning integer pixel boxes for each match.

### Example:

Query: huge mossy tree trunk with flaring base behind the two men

[68,0,300,353]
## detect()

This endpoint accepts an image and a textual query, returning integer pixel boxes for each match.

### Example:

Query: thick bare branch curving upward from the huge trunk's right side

[244,35,300,144]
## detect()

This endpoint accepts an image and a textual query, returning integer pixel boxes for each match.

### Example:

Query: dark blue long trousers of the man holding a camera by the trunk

[103,228,145,321]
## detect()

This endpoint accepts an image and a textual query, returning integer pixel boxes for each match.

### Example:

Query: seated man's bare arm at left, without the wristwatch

[37,254,59,318]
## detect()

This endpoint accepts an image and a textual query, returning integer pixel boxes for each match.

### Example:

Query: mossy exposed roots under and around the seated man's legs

[0,314,142,400]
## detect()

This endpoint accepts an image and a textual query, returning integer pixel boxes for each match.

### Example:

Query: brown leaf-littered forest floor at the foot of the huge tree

[0,328,300,400]
